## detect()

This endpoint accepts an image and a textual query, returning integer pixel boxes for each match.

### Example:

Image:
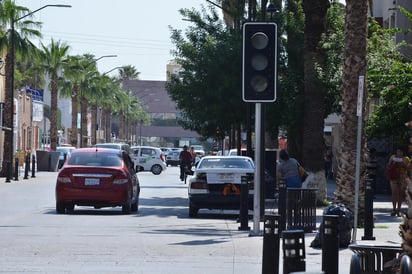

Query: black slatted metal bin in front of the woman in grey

[286,188,318,232]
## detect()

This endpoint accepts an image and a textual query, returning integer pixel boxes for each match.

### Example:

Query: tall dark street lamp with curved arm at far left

[6,4,72,183]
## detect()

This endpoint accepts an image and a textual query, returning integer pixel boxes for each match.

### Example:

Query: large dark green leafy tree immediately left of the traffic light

[166,5,246,137]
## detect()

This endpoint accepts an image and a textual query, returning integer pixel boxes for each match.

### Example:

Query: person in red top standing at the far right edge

[388,148,411,217]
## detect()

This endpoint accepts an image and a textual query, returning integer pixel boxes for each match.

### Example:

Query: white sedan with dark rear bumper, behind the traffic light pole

[188,156,255,217]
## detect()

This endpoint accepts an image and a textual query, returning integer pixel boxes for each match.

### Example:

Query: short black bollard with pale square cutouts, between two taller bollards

[282,230,304,274]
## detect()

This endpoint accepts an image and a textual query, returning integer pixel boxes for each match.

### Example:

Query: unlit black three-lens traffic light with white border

[242,22,277,103]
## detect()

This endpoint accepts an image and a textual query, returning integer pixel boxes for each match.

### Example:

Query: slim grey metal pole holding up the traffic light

[252,103,262,236]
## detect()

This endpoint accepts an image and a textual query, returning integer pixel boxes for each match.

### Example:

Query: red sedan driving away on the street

[56,148,140,214]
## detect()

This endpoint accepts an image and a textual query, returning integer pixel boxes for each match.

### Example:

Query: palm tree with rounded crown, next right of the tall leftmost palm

[38,39,70,151]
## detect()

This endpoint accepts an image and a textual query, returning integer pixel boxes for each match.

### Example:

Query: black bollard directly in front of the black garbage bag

[321,215,339,274]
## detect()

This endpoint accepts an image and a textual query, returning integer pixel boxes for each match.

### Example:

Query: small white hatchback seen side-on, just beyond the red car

[131,146,166,175]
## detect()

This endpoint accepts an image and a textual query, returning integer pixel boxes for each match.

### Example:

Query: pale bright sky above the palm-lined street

[15,0,208,80]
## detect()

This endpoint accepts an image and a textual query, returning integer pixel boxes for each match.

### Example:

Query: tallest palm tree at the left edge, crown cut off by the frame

[0,0,41,177]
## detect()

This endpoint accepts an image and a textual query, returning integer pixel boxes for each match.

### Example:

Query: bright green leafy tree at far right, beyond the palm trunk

[366,23,412,146]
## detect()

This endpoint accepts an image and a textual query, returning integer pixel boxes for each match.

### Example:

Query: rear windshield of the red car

[69,152,122,166]
